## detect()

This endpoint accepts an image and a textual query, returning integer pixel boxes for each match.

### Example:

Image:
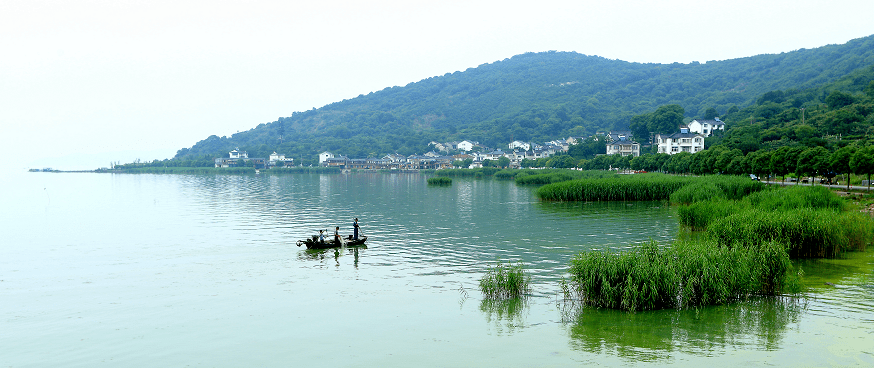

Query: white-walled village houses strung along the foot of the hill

[215,118,725,170]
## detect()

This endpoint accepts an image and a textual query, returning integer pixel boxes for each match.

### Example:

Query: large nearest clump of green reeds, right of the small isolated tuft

[562,241,800,311]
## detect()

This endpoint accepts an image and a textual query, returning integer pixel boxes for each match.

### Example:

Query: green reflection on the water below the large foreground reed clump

[566,298,808,362]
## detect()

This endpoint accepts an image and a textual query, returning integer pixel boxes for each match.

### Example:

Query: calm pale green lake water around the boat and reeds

[0,173,874,367]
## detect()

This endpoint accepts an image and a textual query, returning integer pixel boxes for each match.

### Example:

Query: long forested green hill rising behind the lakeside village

[176,36,874,162]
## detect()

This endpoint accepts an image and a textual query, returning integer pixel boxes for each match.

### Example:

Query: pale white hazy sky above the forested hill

[0,0,874,169]
